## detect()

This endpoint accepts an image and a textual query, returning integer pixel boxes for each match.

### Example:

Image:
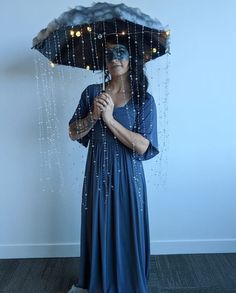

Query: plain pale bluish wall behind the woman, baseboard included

[0,0,236,258]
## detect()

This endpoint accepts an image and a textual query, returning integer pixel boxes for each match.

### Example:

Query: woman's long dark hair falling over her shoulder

[104,36,149,103]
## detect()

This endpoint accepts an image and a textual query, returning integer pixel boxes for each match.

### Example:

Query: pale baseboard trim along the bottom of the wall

[0,239,236,259]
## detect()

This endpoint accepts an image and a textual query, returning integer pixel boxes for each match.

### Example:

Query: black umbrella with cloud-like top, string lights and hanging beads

[32,2,169,86]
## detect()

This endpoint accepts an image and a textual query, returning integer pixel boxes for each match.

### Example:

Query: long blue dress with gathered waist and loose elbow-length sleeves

[69,84,159,293]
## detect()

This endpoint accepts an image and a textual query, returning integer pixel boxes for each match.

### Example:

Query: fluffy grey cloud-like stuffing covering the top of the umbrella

[33,2,164,46]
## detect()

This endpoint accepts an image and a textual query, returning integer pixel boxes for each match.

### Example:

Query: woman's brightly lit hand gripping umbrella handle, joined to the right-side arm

[96,93,114,123]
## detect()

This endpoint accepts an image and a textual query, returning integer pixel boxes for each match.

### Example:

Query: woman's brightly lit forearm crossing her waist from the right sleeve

[107,118,150,155]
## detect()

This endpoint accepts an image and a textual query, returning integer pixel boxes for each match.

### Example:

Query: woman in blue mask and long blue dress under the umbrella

[69,42,159,293]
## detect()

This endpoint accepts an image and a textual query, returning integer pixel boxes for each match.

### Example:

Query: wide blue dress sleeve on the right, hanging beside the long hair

[135,93,159,161]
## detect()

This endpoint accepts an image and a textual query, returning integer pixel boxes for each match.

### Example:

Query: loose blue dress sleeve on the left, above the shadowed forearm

[69,86,92,147]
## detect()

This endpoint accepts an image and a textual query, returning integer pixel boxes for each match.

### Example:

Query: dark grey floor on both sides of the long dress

[0,253,236,293]
